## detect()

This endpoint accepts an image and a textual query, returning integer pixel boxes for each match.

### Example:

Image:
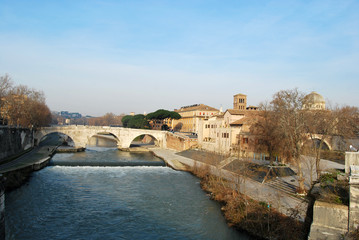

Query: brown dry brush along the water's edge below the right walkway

[193,167,306,240]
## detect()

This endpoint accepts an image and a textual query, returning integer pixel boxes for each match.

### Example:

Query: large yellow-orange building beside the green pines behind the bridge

[172,104,219,134]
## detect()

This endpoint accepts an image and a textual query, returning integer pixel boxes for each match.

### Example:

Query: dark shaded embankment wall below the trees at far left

[0,127,34,162]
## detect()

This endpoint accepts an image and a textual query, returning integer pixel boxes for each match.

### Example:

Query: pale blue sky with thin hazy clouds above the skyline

[0,0,359,116]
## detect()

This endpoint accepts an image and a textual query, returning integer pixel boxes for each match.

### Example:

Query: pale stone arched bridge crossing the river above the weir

[34,125,167,148]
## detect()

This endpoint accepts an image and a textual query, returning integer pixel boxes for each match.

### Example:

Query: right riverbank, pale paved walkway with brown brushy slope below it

[150,148,308,239]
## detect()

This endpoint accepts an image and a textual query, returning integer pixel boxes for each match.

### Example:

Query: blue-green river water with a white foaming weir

[6,149,249,240]
